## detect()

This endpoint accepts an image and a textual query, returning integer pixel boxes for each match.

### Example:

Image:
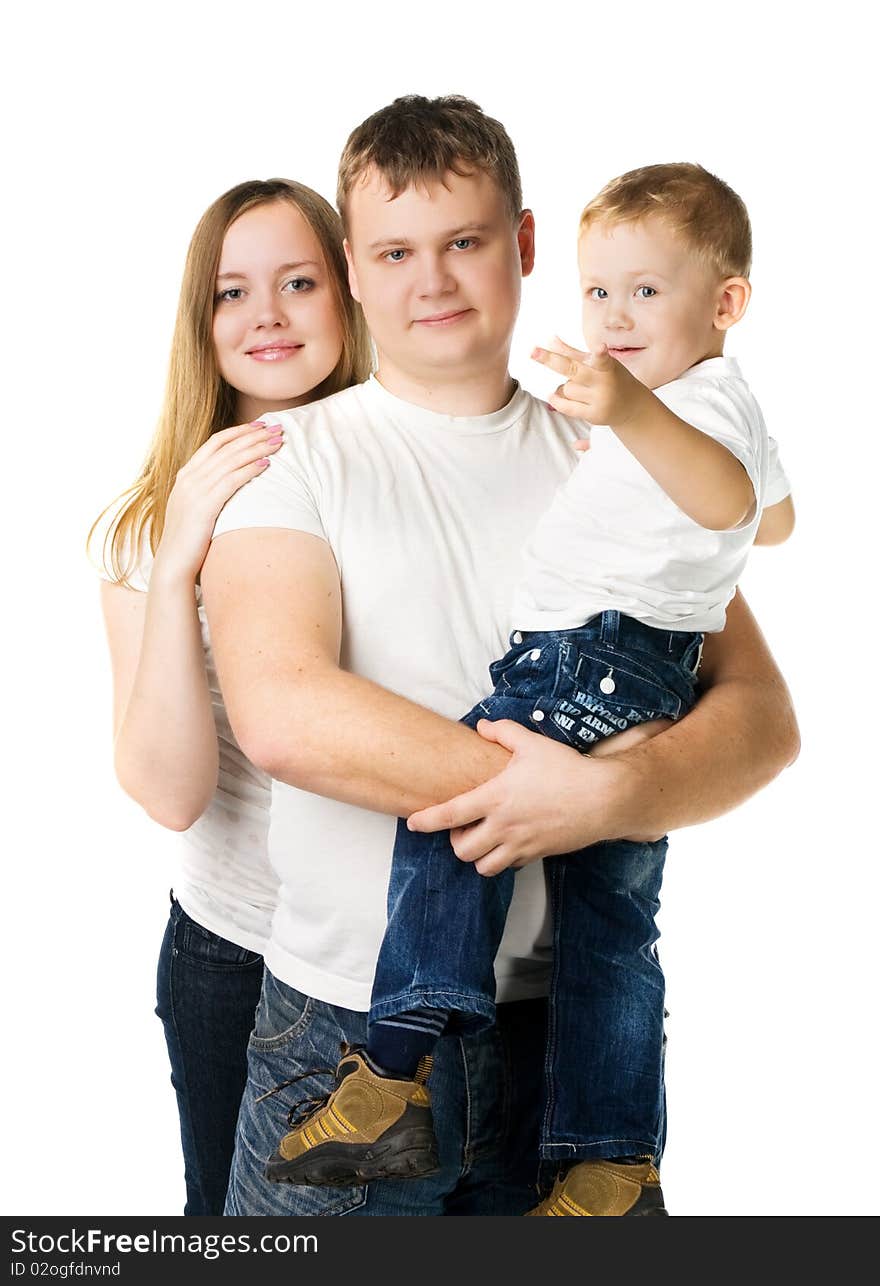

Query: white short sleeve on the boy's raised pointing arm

[655,379,764,503]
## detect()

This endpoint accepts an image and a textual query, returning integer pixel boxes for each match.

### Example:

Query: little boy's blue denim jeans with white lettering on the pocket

[369,612,702,1161]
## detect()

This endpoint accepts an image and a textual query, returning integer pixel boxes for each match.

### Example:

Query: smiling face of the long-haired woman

[214,201,342,422]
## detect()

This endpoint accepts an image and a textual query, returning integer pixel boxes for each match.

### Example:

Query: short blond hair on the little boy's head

[580,161,751,276]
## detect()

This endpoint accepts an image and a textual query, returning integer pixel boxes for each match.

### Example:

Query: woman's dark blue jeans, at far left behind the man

[156,900,262,1215]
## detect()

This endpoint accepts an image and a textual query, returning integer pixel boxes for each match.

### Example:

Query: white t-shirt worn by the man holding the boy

[215,378,584,1011]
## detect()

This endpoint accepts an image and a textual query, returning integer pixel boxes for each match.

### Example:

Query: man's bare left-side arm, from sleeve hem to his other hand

[202,527,509,815]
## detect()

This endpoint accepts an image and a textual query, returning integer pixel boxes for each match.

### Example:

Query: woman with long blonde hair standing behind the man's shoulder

[90,179,369,1215]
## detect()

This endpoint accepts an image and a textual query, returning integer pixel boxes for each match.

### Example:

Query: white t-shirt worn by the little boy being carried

[512,358,790,631]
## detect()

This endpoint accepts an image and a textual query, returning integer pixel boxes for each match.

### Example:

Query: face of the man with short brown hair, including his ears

[346,170,534,383]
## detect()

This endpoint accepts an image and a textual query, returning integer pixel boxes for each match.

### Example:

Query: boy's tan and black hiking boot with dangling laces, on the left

[262,1049,440,1187]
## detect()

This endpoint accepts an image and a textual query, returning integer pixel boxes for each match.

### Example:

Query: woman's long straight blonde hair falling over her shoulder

[89,179,371,584]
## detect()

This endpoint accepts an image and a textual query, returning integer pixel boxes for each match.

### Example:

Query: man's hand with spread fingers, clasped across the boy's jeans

[408,719,638,876]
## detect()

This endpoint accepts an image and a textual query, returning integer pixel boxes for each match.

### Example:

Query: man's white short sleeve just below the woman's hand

[214,412,327,540]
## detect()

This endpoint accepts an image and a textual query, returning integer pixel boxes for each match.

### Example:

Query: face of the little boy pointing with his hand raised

[578,216,723,388]
